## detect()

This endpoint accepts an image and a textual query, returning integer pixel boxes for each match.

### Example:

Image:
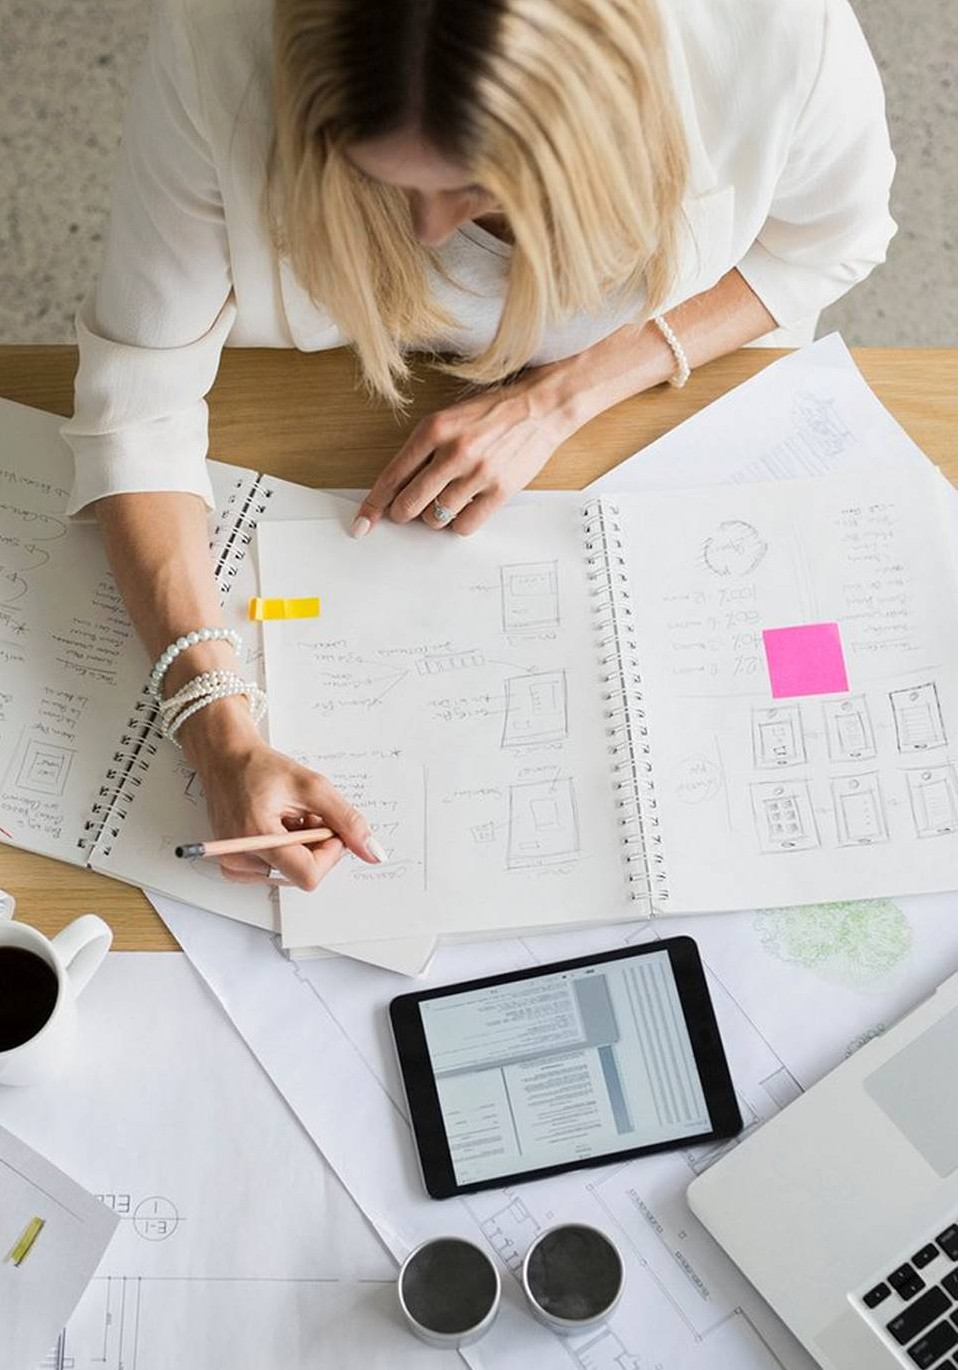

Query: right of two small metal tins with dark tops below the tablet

[522,1223,623,1333]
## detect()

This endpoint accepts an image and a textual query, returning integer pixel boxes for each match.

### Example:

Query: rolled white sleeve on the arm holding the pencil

[63,0,236,514]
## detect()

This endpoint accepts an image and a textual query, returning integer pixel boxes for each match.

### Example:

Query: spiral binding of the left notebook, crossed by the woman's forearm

[77,475,273,858]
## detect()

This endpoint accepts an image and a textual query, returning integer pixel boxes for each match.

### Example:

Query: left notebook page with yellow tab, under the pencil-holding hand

[259,497,630,947]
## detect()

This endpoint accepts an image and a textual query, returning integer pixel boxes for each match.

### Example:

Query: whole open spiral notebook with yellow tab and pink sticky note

[257,469,957,948]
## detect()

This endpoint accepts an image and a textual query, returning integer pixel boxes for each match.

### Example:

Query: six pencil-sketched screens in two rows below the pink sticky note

[750,681,957,852]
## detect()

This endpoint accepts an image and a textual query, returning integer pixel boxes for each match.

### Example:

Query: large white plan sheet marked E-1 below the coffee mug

[0,959,459,1370]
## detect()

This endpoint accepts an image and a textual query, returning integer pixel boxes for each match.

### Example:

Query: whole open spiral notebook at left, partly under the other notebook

[0,400,431,967]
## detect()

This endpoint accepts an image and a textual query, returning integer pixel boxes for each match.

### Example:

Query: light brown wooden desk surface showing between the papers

[0,347,957,951]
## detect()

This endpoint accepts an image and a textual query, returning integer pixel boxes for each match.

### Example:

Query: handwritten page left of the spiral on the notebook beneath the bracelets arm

[0,400,148,864]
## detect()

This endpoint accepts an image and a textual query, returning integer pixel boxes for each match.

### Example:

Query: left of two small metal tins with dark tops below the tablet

[397,1237,500,1347]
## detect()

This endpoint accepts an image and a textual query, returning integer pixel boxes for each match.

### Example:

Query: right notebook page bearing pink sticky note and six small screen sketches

[618,469,957,912]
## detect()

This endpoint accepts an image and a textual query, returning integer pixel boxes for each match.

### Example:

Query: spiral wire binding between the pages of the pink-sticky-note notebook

[583,500,670,912]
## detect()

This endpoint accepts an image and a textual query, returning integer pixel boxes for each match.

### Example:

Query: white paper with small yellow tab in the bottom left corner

[0,1123,118,1370]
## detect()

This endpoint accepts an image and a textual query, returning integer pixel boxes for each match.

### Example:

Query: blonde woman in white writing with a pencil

[66,0,894,888]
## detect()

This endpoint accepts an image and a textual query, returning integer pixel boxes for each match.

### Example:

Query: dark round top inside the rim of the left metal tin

[403,1237,497,1333]
